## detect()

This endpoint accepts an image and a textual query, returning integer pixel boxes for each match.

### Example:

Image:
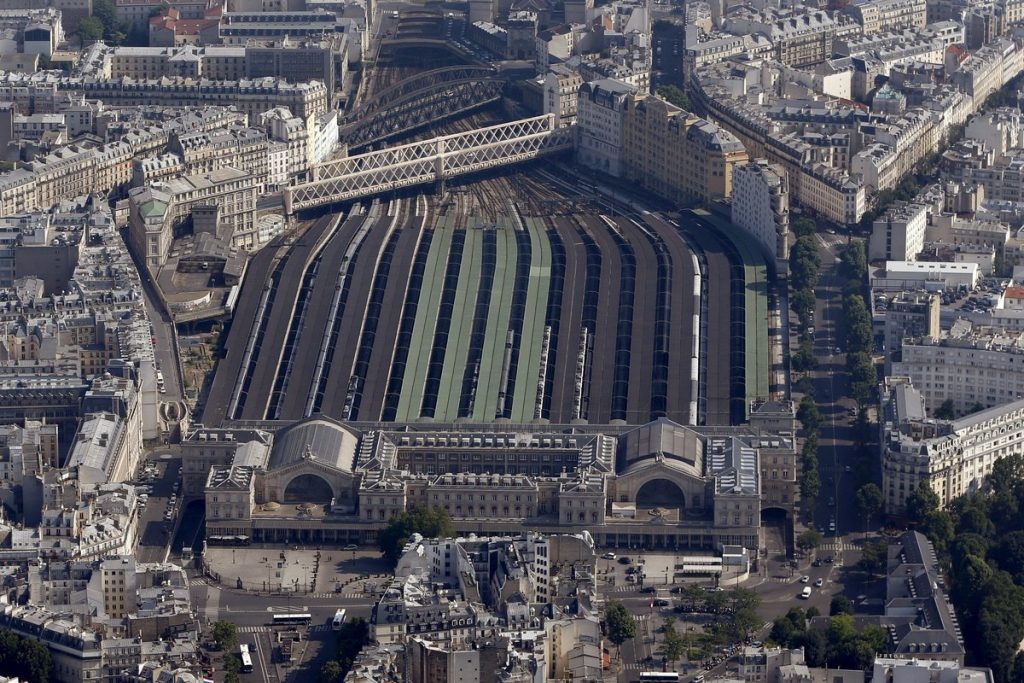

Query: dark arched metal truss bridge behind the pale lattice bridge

[341,67,505,150]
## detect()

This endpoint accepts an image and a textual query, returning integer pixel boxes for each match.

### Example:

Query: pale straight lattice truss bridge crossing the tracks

[285,114,573,214]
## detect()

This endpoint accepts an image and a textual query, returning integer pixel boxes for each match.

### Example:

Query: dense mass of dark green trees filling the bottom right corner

[906,454,1024,683]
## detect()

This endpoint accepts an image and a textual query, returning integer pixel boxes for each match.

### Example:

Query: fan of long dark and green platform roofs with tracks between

[209,166,743,424]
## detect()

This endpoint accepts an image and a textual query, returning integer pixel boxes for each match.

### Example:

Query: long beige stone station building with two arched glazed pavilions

[192,413,796,550]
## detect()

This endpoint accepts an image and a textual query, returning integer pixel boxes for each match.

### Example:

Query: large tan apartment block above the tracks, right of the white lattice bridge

[623,94,749,206]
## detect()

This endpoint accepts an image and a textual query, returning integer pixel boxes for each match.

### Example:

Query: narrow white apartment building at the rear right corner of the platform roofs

[732,159,790,262]
